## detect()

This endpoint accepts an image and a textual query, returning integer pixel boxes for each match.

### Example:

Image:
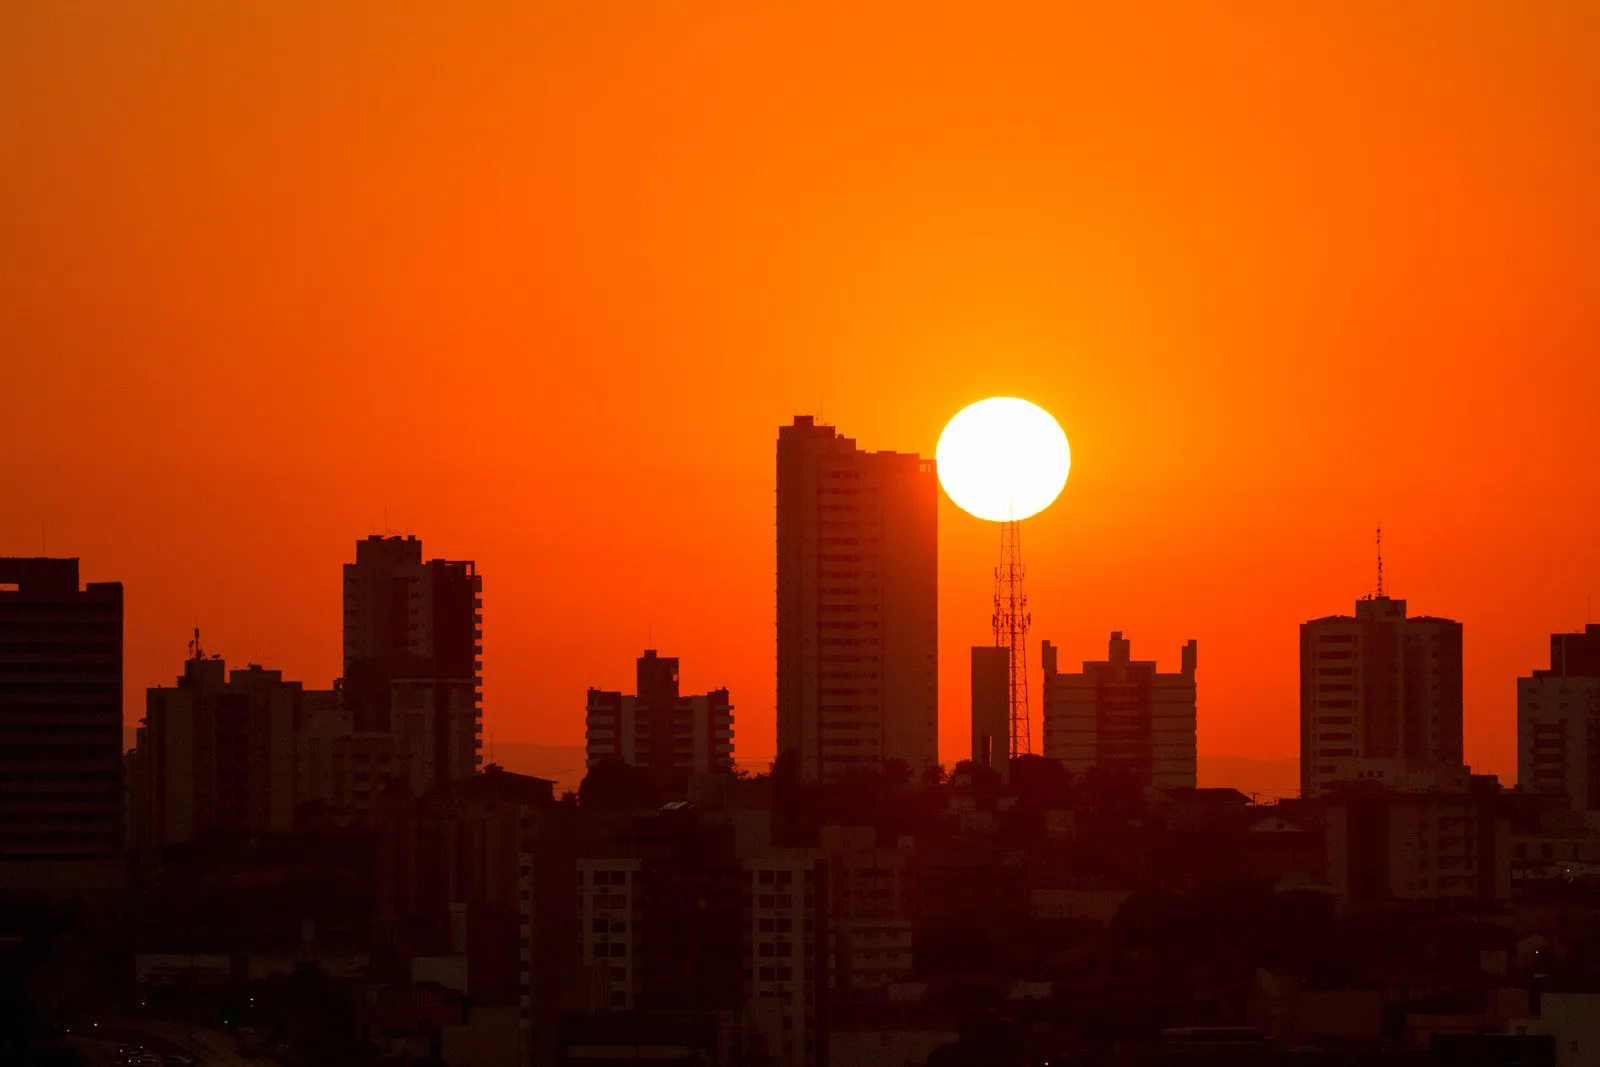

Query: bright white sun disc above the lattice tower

[934,397,1072,523]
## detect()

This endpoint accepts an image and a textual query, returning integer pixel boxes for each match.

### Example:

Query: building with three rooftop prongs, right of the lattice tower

[1043,630,1197,789]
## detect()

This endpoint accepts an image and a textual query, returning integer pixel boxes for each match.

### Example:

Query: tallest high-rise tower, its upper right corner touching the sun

[778,416,939,781]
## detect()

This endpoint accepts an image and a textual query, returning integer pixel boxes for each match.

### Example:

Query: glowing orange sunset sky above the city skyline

[0,0,1600,774]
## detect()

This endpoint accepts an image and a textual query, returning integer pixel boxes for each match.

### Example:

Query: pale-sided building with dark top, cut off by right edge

[1517,622,1600,811]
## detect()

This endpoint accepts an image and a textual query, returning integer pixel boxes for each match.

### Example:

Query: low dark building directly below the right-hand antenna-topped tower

[1318,776,1512,905]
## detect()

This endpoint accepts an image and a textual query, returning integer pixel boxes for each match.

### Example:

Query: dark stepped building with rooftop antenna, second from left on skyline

[131,652,334,854]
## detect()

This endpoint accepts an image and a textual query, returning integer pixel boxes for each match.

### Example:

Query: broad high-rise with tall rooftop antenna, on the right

[1301,595,1461,797]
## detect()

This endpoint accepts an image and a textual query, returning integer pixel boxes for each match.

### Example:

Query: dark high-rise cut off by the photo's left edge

[0,558,126,891]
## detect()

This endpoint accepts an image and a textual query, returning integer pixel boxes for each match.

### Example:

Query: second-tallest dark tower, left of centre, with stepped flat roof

[344,534,483,785]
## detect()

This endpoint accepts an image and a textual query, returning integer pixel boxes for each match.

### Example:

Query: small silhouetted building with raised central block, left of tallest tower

[584,648,733,774]
